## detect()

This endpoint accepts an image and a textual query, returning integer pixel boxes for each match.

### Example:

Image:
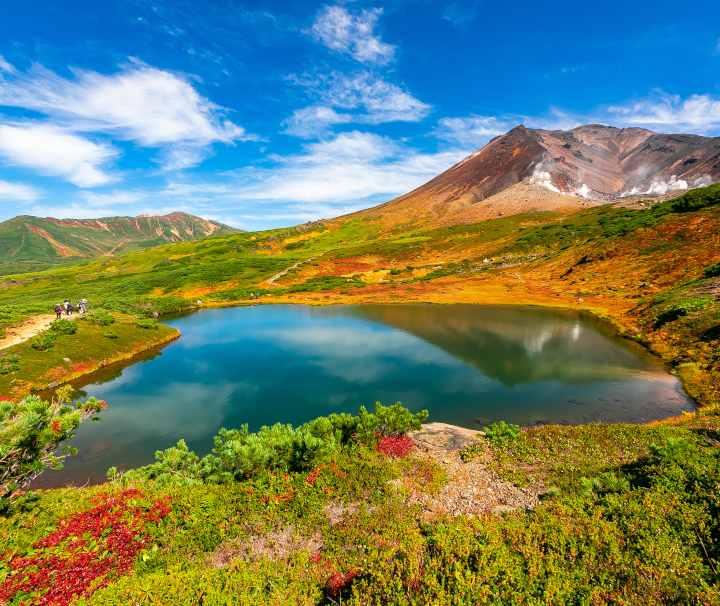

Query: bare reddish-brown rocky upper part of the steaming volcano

[416,124,720,201]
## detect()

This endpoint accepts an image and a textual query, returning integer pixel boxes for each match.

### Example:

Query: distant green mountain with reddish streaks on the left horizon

[0,212,238,275]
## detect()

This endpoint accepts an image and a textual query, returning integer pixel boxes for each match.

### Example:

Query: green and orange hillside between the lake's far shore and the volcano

[0,186,720,406]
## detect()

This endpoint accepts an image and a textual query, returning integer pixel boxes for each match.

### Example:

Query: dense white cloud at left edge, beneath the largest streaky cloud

[0,123,117,187]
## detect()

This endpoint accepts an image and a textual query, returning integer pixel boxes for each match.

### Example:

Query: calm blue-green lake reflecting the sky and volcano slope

[42,304,693,486]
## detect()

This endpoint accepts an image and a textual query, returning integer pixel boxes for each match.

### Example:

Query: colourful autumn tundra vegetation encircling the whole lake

[0,186,720,605]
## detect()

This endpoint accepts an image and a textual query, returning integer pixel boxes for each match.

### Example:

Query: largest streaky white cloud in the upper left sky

[0,62,254,169]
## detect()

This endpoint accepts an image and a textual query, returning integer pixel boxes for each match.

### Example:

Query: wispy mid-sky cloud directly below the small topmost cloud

[285,71,431,137]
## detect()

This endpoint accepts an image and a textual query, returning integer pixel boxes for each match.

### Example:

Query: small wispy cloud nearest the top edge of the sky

[311,6,395,65]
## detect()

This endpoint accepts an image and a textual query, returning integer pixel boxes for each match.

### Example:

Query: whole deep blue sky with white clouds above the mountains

[0,0,720,229]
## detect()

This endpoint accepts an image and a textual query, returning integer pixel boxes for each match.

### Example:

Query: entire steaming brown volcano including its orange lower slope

[360,124,720,225]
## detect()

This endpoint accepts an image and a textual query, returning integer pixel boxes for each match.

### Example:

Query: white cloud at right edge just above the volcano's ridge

[607,92,720,133]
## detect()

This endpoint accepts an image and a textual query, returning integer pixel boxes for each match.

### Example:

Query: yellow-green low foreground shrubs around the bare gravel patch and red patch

[0,413,720,606]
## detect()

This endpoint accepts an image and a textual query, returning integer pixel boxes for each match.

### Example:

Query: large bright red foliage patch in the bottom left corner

[0,488,171,606]
